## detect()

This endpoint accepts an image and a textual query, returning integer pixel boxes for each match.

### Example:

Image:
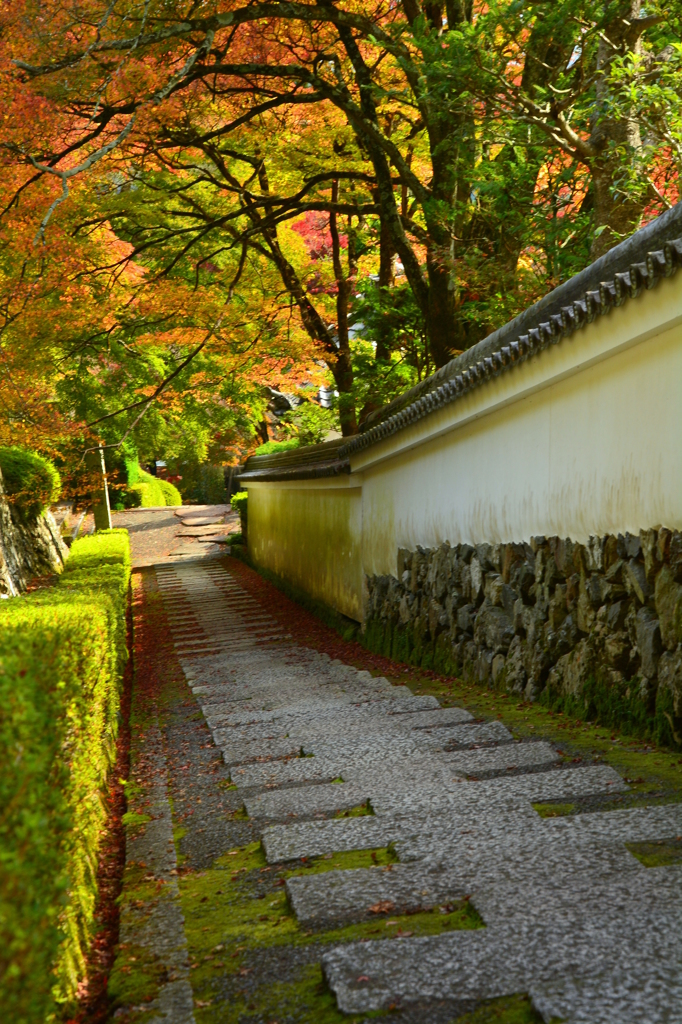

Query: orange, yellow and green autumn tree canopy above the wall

[0,0,682,475]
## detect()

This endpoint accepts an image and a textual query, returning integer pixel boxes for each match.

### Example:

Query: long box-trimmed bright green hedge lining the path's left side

[0,530,130,1024]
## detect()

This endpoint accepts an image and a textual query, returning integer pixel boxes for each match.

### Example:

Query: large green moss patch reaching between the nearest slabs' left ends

[178,843,482,1024]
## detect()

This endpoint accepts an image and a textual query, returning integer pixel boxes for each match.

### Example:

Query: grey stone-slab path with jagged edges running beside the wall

[120,559,682,1024]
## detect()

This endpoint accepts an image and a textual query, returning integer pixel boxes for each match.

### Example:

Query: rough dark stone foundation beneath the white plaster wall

[365,528,682,746]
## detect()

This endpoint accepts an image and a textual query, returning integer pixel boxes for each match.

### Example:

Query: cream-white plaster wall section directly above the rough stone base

[353,274,682,573]
